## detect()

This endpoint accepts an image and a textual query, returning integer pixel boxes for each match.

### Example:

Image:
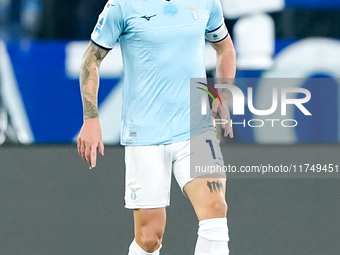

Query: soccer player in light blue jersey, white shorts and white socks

[78,0,236,255]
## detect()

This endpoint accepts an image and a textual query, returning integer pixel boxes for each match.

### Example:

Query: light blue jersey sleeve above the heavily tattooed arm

[91,0,124,50]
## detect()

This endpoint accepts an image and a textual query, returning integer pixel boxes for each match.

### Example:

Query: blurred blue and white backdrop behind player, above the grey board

[0,0,340,144]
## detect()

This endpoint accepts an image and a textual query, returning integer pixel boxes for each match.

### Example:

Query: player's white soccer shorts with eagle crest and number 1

[125,131,225,209]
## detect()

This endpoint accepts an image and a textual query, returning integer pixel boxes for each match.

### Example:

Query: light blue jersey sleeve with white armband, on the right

[205,0,229,42]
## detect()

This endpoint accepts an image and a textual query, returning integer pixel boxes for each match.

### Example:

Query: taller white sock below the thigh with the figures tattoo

[195,218,229,255]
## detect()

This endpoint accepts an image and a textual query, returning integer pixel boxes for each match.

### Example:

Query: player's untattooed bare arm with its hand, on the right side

[211,35,236,138]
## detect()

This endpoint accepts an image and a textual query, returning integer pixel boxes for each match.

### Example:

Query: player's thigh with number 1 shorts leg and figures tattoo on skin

[174,131,227,220]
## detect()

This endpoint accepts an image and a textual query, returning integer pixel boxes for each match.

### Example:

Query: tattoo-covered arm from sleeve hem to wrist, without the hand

[79,43,108,119]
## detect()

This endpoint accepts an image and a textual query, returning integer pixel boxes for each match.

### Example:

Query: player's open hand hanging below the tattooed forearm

[77,118,104,168]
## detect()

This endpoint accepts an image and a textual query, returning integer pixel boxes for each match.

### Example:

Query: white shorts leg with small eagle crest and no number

[125,145,171,209]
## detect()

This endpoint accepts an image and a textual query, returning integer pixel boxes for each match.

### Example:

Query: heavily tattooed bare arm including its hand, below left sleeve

[78,42,108,167]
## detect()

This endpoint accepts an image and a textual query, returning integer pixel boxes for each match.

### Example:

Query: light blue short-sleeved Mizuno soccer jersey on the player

[91,0,228,145]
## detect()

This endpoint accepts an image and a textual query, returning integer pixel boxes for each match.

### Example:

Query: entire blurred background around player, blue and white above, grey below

[0,0,340,255]
